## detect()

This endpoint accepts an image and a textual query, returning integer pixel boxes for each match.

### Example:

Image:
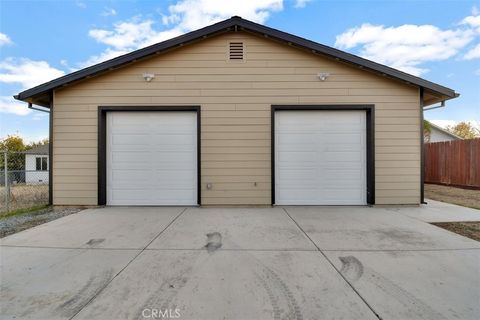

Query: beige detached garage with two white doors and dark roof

[15,17,458,206]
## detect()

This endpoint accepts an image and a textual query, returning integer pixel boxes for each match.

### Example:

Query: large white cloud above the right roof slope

[335,24,475,75]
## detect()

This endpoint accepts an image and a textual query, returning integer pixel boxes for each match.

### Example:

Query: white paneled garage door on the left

[107,111,197,205]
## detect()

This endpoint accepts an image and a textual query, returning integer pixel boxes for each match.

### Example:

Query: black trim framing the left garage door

[97,106,202,206]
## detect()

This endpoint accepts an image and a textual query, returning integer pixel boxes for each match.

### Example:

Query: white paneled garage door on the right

[275,111,367,205]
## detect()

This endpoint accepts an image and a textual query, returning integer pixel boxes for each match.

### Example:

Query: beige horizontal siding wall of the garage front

[53,33,420,205]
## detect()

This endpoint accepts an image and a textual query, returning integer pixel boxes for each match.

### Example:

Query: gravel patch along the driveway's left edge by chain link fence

[0,208,83,238]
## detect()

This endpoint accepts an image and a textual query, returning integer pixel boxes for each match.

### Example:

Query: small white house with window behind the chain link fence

[25,144,49,184]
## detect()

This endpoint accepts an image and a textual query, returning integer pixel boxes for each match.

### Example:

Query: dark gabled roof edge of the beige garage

[14,16,458,107]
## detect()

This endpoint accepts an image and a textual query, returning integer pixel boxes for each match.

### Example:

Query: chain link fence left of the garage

[0,148,49,213]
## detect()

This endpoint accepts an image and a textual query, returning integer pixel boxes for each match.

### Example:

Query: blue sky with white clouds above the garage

[0,0,480,141]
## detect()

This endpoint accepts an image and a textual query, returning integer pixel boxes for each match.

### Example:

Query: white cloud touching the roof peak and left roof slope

[79,0,283,67]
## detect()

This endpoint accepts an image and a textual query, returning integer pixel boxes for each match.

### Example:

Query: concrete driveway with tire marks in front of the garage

[0,203,480,320]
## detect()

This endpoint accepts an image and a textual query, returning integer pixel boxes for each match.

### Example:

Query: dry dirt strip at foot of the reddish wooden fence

[425,184,480,209]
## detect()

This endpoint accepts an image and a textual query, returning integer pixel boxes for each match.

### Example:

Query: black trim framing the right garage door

[270,104,375,205]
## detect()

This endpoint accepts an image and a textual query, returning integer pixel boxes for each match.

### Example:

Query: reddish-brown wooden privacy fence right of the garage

[425,139,480,189]
